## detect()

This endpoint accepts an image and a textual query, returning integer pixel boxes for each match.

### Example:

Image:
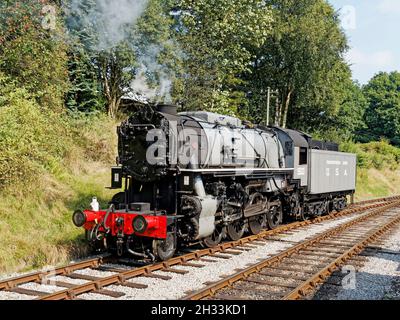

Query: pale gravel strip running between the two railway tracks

[79,211,368,300]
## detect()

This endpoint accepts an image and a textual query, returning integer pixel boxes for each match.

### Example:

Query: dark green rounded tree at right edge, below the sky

[360,71,400,145]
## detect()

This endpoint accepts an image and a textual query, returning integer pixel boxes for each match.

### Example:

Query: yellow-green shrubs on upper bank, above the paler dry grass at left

[0,74,114,190]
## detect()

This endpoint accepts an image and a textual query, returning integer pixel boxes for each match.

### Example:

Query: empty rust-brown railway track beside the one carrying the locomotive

[185,201,400,300]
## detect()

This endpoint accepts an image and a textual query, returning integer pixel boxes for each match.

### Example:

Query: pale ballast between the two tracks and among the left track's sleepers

[0,211,394,300]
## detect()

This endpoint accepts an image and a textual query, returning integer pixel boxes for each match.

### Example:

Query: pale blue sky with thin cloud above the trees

[328,0,400,84]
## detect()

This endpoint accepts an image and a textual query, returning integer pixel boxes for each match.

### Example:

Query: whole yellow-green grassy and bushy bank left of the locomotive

[0,77,122,273]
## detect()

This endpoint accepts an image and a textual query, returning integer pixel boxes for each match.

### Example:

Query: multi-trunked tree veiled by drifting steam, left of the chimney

[66,0,174,117]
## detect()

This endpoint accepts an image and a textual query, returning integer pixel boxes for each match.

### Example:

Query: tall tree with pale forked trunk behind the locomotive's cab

[245,0,351,128]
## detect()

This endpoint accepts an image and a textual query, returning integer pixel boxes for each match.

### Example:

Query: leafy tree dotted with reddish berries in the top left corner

[0,0,68,111]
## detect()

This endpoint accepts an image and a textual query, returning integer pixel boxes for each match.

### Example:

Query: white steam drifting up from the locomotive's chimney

[68,0,172,103]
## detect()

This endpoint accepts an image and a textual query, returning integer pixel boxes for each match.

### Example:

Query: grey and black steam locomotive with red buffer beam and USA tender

[73,105,356,261]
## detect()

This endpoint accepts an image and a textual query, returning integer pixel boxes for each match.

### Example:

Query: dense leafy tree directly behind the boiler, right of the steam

[175,0,271,114]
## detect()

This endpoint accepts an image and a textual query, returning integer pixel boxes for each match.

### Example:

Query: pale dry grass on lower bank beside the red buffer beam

[0,165,119,272]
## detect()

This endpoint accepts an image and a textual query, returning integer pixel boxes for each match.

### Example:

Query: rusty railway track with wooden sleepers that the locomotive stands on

[0,196,400,300]
